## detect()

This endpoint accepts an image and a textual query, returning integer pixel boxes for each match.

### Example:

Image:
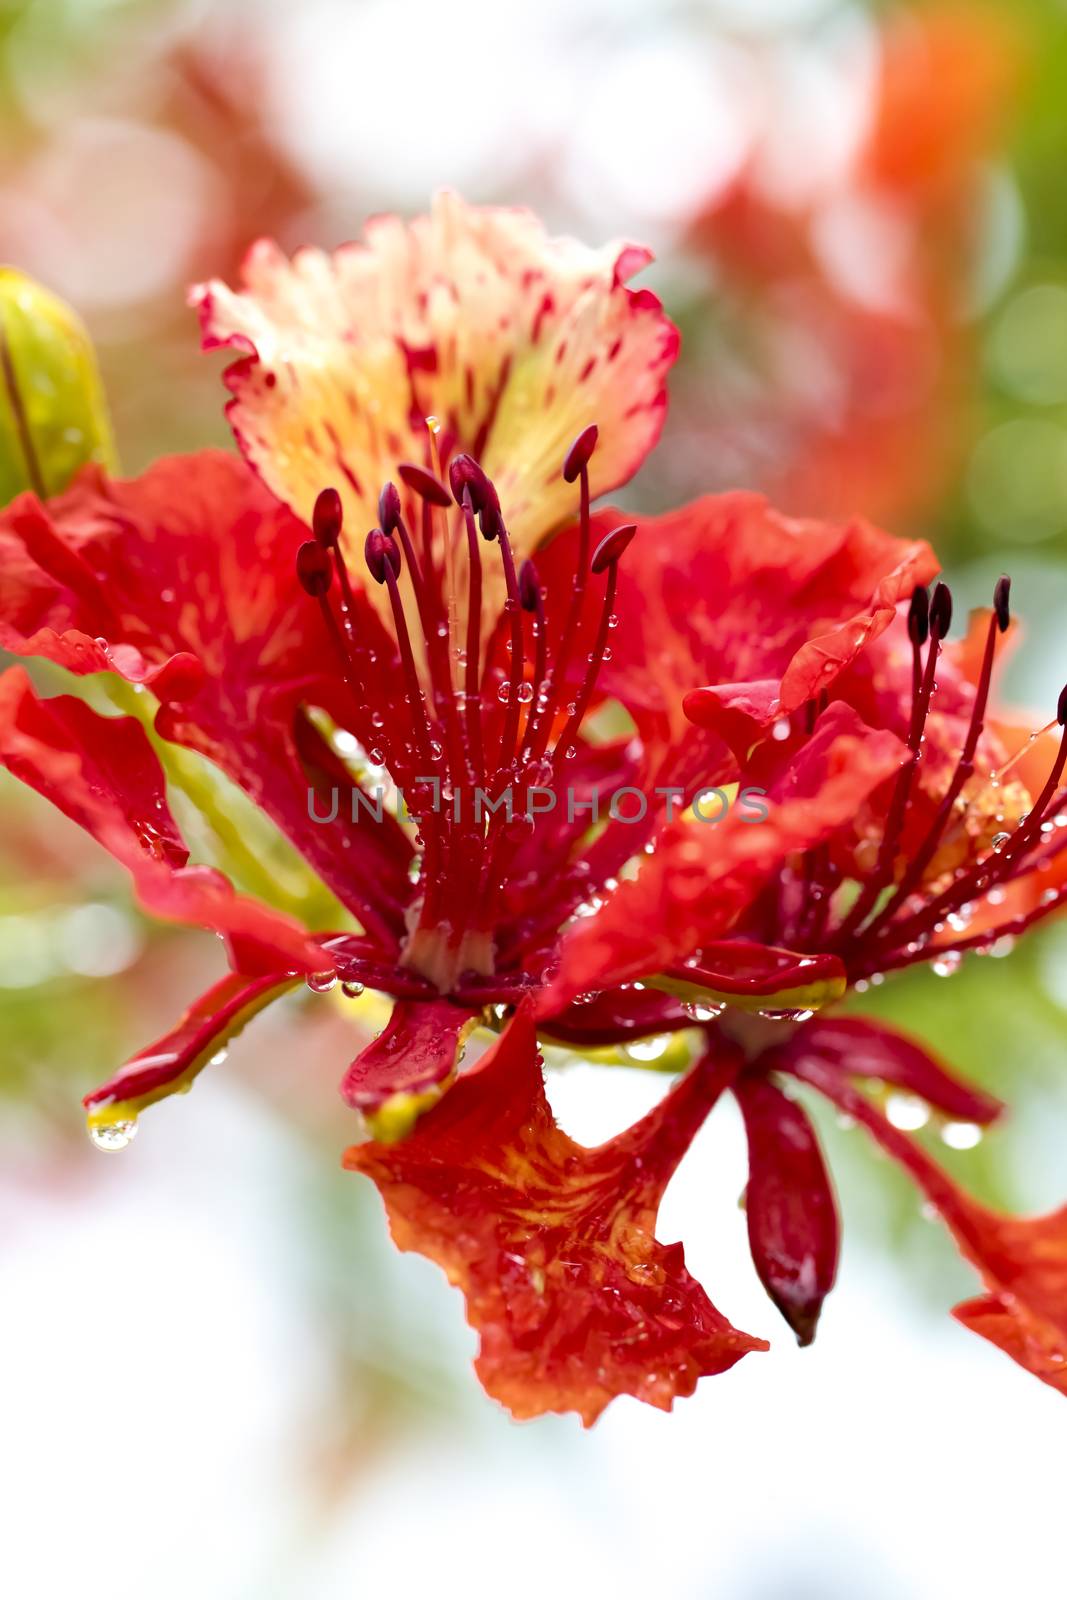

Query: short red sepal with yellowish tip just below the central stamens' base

[341,1000,475,1144]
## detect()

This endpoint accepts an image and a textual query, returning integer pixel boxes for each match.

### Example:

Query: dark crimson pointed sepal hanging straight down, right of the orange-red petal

[734,1074,838,1344]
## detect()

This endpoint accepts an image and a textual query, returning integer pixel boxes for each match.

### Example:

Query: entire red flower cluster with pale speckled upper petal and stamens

[0,197,1067,1422]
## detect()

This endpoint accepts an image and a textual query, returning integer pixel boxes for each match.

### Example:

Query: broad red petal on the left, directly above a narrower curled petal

[0,451,411,949]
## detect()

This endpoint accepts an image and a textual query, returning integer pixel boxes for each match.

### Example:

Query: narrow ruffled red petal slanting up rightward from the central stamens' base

[542,702,904,1016]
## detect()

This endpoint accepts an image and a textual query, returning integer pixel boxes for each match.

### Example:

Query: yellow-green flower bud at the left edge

[0,267,115,506]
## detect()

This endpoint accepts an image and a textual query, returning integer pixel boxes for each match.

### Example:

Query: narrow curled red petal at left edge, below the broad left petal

[0,667,330,973]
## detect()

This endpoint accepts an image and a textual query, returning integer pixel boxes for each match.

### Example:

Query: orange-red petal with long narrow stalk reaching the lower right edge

[797,1061,1067,1394]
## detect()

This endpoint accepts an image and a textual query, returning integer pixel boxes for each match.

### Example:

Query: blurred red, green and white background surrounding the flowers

[0,0,1067,1600]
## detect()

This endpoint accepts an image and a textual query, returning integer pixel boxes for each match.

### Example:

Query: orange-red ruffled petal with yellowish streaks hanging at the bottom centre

[346,1013,766,1426]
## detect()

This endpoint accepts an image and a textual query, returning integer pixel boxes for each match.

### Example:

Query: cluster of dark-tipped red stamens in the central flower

[298,426,635,992]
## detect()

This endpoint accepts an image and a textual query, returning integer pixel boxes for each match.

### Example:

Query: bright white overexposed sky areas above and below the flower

[0,0,1065,1600]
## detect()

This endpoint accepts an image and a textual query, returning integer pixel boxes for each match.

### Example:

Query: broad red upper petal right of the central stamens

[537,493,937,764]
